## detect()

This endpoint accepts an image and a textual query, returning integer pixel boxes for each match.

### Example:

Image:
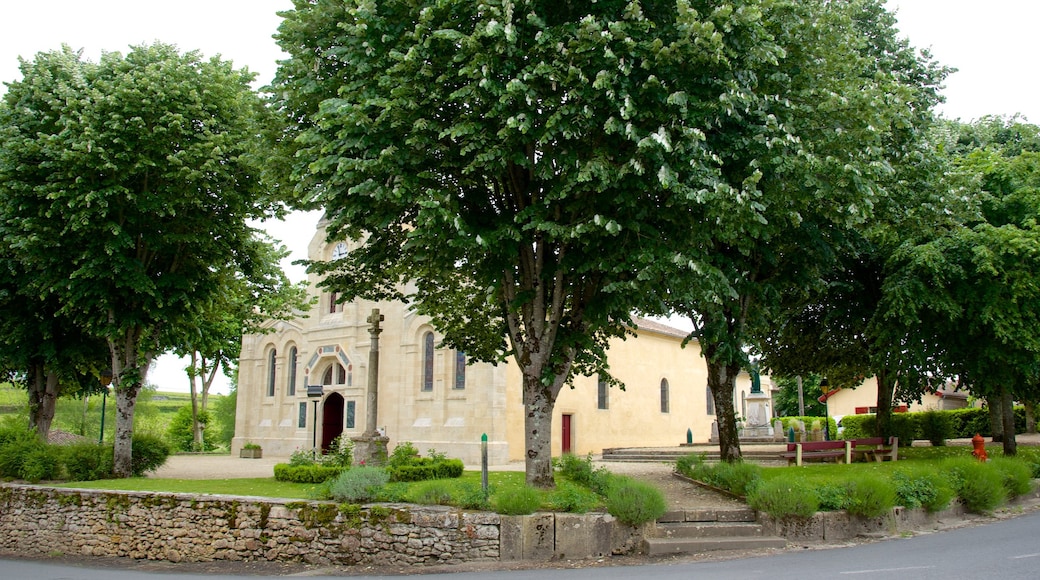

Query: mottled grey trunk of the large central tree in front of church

[523,374,558,490]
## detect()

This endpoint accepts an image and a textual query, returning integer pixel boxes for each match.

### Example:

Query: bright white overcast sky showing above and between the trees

[0,0,1040,392]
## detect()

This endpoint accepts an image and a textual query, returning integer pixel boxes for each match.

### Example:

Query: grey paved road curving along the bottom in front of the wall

[8,511,1040,580]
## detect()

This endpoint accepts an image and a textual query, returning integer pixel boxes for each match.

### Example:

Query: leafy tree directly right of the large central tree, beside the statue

[665,0,945,460]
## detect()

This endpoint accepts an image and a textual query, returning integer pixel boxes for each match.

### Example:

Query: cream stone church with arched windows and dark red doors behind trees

[232,222,751,465]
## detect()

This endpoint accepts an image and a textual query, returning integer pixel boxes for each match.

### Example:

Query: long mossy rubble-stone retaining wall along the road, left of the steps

[0,484,643,565]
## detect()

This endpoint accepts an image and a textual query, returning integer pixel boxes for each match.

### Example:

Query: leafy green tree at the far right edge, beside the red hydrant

[886,118,1040,455]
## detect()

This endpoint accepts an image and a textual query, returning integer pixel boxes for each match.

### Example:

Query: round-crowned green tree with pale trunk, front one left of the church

[0,44,284,476]
